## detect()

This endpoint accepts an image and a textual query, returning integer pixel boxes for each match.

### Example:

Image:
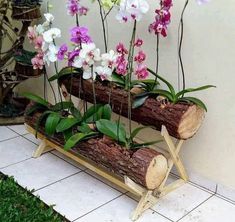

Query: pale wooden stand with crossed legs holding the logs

[25,125,188,221]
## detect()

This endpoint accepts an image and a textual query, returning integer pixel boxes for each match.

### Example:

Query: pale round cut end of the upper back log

[178,105,205,139]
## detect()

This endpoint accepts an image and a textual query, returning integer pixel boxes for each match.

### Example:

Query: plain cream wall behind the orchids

[15,0,235,189]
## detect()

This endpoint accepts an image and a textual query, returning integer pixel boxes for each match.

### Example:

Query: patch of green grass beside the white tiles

[0,172,68,222]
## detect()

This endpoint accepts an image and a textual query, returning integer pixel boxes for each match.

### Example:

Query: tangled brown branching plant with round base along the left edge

[0,0,44,125]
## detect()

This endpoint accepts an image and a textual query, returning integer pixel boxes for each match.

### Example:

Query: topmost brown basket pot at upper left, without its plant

[12,5,41,21]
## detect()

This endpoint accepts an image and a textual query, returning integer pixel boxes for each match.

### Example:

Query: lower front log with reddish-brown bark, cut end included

[25,110,168,190]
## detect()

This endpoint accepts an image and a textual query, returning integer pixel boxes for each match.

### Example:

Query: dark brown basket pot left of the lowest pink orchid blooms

[15,61,46,78]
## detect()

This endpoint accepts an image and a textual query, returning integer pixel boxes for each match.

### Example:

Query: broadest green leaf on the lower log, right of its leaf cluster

[96,119,127,144]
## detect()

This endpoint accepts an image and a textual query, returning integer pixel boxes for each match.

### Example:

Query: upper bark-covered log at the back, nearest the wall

[60,76,205,140]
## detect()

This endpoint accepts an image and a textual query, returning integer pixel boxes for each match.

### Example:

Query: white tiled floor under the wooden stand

[0,126,235,222]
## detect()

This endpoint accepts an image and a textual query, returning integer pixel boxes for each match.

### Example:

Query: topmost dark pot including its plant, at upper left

[11,0,42,21]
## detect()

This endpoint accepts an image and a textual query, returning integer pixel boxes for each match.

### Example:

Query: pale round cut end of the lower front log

[145,155,167,190]
